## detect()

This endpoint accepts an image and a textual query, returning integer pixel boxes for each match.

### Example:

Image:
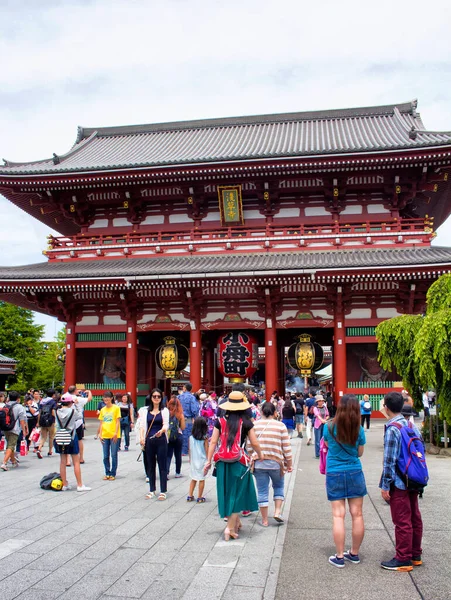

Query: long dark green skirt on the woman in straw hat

[216,461,258,518]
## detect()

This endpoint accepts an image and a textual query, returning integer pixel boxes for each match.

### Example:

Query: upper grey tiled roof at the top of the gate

[0,101,451,175]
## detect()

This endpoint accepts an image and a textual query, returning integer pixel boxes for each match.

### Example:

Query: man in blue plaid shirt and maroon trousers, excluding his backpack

[379,392,423,571]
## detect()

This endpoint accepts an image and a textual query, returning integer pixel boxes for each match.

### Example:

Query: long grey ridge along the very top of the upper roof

[76,100,417,143]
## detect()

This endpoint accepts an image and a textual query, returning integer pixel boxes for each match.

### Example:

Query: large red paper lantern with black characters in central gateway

[217,331,258,383]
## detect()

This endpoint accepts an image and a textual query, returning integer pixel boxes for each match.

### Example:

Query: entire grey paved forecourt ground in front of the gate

[0,423,451,600]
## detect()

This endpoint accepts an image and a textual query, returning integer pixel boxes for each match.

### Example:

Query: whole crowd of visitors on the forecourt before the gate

[0,382,430,571]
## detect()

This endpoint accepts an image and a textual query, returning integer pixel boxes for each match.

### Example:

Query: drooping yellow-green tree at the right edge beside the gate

[376,275,451,422]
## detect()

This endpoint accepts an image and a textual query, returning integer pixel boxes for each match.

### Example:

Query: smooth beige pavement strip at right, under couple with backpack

[276,421,451,600]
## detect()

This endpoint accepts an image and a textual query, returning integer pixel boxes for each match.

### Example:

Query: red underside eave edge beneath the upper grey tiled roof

[0,144,451,191]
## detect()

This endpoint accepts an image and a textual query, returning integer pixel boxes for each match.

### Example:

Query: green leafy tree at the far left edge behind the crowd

[0,302,44,391]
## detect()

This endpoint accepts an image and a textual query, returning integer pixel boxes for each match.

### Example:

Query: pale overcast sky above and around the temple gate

[0,0,451,338]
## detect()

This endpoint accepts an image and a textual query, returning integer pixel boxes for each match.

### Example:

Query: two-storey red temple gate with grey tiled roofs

[0,102,451,408]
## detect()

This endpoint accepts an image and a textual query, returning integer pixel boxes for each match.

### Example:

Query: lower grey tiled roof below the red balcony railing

[0,247,451,288]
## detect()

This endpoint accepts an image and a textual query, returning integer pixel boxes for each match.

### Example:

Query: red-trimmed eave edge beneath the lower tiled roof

[0,261,451,294]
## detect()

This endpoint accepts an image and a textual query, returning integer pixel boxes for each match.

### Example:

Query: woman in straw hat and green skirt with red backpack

[204,391,263,541]
